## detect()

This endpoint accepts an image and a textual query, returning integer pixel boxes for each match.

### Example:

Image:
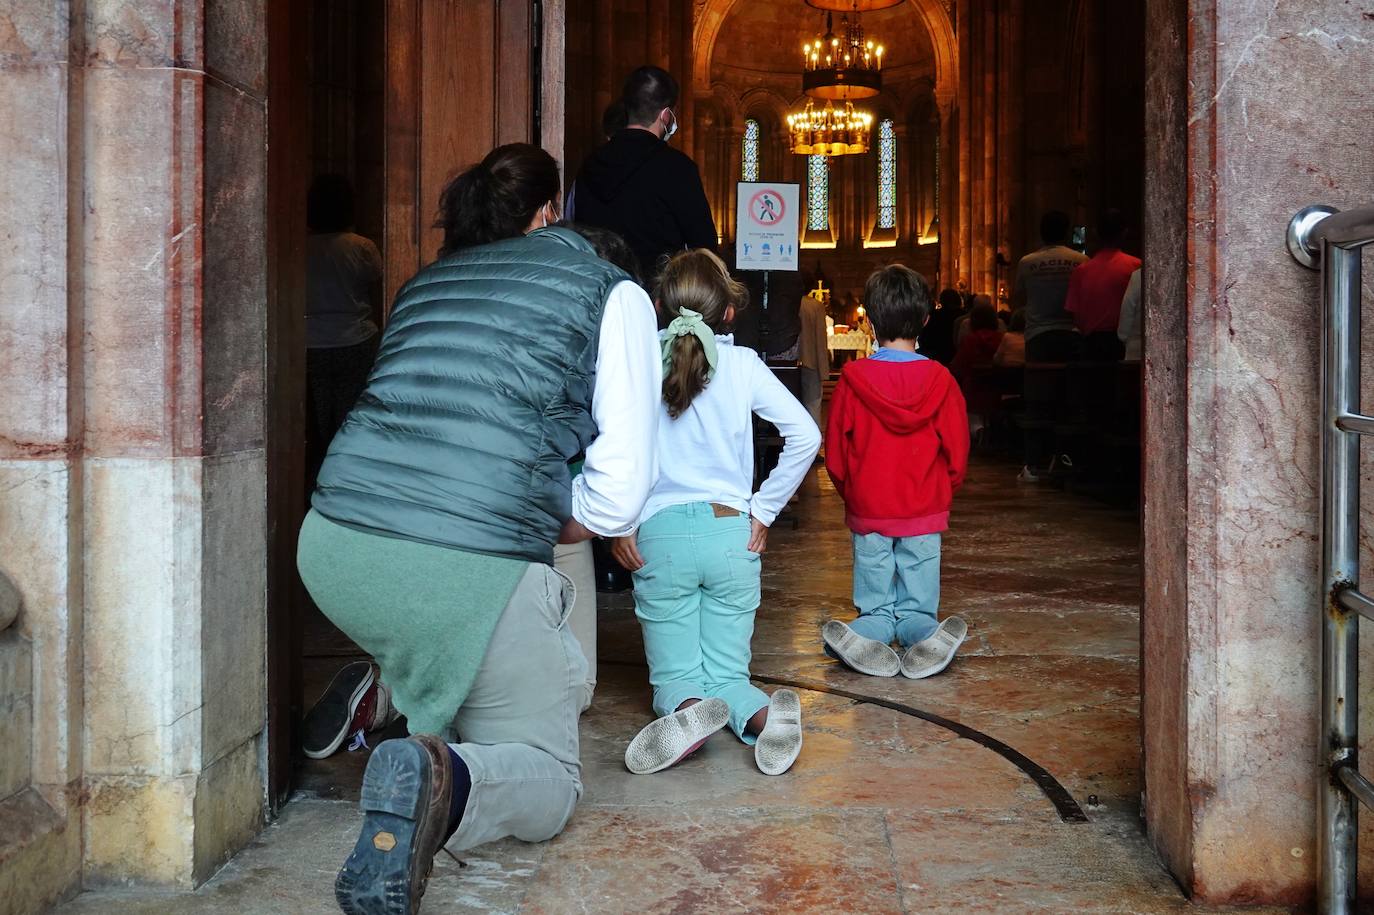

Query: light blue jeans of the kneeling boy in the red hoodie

[849,533,940,648]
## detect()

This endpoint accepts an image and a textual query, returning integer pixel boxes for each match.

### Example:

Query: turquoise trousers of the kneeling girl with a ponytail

[635,501,768,743]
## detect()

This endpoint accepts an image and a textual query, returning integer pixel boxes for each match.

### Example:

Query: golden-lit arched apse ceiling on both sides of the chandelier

[692,0,958,107]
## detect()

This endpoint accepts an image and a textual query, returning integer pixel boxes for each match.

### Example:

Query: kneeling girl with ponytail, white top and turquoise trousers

[613,250,820,775]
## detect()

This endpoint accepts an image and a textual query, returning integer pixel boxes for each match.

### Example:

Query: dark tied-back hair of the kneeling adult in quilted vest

[437,143,558,257]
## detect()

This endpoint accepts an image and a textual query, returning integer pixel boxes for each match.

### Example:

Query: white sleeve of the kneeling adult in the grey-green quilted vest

[573,280,662,537]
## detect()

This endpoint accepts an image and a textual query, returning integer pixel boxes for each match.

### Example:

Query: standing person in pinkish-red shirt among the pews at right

[1063,210,1140,363]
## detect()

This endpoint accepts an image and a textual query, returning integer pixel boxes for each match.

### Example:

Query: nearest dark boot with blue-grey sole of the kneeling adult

[334,735,453,915]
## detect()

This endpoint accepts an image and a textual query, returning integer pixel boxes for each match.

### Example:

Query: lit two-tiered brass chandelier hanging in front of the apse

[787,0,885,157]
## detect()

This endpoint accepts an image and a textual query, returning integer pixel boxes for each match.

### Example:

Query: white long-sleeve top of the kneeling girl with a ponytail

[640,337,820,525]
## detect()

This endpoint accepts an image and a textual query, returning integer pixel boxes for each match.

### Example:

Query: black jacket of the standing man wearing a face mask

[574,128,716,276]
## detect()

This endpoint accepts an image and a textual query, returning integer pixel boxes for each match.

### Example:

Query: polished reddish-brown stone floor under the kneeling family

[60,463,1291,915]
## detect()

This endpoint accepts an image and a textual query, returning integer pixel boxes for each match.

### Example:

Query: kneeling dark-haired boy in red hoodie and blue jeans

[820,265,969,679]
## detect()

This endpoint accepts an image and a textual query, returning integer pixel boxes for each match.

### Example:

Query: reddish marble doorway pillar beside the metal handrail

[1143,0,1374,904]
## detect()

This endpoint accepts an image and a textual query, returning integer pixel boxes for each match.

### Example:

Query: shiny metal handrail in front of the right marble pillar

[1287,206,1374,915]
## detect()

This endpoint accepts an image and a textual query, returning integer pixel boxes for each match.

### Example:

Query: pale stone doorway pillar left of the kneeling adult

[0,0,267,895]
